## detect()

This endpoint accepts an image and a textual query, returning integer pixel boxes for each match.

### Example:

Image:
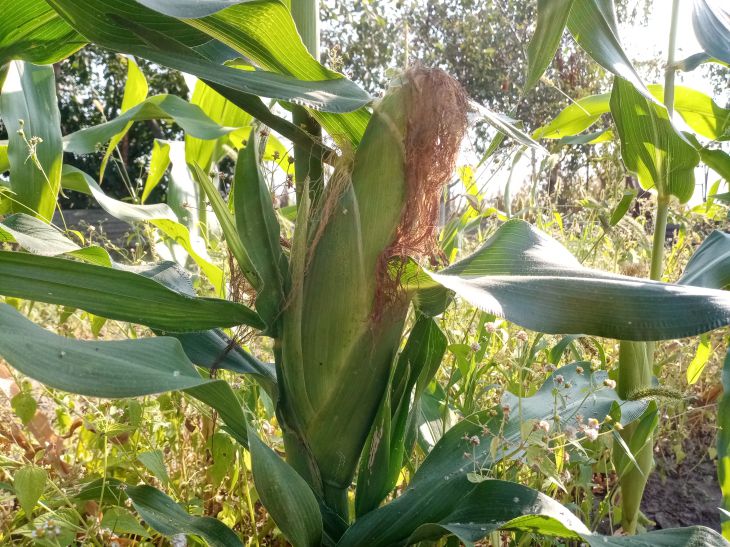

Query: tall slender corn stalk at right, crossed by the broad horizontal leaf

[614,0,679,534]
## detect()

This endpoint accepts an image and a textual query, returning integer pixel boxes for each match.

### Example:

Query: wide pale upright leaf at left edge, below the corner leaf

[0,61,63,222]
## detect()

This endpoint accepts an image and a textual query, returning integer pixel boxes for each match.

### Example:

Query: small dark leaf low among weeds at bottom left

[124,485,243,547]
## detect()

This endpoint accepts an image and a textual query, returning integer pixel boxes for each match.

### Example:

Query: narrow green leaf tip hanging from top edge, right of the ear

[525,0,573,90]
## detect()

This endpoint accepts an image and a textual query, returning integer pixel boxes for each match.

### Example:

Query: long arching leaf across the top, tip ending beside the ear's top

[48,0,370,112]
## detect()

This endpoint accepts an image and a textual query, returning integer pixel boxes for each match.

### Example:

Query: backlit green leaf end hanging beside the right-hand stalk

[611,78,700,203]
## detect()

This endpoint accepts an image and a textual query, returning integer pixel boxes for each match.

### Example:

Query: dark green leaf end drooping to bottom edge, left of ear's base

[248,430,322,547]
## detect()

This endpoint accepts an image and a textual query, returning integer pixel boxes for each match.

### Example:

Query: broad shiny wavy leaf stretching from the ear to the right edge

[412,220,730,340]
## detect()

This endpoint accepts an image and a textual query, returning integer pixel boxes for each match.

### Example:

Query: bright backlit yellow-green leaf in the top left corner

[0,0,86,66]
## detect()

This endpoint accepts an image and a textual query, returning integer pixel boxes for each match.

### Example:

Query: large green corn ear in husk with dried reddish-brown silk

[282,69,466,514]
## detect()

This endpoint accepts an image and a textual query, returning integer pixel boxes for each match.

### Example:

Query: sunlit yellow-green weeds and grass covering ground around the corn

[0,182,730,546]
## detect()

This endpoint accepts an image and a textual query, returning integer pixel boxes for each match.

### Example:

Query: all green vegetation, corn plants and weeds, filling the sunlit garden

[0,0,730,546]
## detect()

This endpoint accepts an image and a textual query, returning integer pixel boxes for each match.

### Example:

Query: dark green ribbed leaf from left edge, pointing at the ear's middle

[0,251,264,332]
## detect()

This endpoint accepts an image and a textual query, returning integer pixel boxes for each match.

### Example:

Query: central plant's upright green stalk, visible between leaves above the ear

[291,0,324,204]
